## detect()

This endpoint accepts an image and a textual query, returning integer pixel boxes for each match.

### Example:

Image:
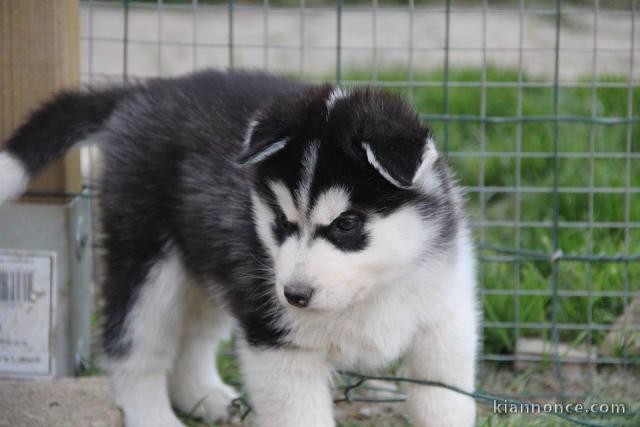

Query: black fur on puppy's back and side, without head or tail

[95,71,303,356]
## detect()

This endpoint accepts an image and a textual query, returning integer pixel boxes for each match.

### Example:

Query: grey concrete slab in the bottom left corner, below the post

[0,377,122,427]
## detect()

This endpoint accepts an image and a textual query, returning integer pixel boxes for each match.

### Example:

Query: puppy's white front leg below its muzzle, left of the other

[240,343,335,427]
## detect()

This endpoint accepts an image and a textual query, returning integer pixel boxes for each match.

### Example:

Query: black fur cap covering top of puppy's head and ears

[245,86,457,239]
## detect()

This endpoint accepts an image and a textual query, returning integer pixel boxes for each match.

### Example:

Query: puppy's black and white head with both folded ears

[238,86,456,312]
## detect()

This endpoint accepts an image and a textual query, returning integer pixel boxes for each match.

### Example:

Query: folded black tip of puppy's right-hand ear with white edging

[362,134,438,189]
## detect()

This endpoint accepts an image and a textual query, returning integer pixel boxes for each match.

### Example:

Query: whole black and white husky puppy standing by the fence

[0,71,477,427]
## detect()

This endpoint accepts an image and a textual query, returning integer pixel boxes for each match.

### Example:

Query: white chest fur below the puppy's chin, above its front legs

[288,234,475,371]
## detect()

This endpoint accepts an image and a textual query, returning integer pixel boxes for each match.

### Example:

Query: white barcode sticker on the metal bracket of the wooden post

[0,250,55,376]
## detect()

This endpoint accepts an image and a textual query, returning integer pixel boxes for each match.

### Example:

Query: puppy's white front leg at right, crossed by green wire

[408,310,477,427]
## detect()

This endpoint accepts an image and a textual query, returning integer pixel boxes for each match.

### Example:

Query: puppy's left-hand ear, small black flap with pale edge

[236,119,289,166]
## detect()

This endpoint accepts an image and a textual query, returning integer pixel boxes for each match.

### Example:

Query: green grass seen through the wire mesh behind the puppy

[330,67,640,353]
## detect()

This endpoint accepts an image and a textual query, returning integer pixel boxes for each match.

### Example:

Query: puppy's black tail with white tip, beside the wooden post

[0,88,127,205]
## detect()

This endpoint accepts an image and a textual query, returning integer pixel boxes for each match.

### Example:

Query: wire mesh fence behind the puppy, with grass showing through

[81,0,640,408]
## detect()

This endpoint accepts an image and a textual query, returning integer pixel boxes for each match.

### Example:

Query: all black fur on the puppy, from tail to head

[8,71,460,357]
